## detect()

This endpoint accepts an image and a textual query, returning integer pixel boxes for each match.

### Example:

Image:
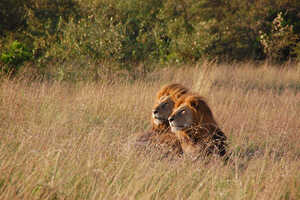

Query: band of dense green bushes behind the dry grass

[0,0,300,79]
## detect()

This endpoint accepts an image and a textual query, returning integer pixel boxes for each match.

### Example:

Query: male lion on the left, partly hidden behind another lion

[136,83,189,154]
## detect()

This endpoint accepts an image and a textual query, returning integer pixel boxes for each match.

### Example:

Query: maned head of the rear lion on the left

[152,83,188,127]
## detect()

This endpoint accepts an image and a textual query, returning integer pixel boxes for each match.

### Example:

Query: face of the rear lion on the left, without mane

[152,96,175,125]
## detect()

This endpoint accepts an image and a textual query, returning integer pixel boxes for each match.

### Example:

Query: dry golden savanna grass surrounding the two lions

[0,63,300,200]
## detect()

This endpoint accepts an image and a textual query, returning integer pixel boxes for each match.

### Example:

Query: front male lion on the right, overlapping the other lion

[168,94,227,159]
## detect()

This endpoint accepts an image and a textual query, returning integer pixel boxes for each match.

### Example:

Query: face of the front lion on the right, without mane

[169,105,194,133]
